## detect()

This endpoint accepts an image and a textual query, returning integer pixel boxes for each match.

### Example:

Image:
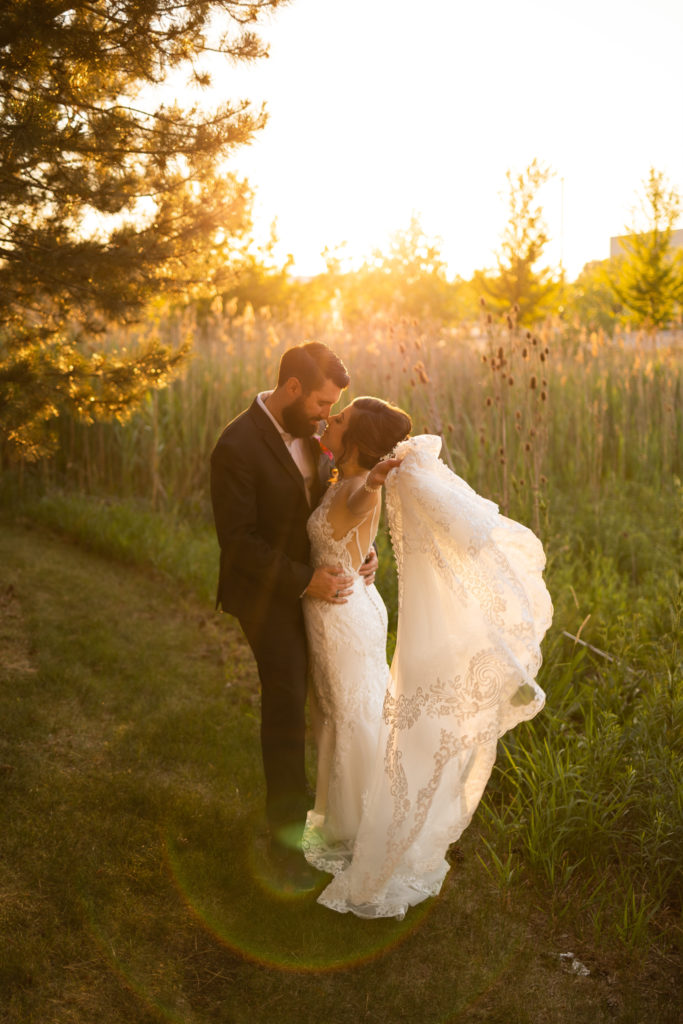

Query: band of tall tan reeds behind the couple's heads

[36,304,683,530]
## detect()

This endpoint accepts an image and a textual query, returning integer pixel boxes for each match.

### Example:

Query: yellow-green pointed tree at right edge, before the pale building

[610,168,683,331]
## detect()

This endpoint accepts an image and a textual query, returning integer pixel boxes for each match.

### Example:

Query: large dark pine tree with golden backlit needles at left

[0,0,285,458]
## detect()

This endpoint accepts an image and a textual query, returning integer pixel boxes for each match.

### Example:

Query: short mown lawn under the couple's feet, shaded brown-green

[0,523,680,1024]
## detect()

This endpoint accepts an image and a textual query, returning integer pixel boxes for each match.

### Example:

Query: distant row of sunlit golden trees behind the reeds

[221,161,683,334]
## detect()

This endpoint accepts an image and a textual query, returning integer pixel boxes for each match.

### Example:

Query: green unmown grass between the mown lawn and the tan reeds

[10,468,683,951]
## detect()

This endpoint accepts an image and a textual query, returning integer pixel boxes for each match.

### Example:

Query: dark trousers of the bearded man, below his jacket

[240,601,309,835]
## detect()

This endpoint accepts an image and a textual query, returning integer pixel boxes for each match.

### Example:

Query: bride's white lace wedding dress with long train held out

[304,435,552,918]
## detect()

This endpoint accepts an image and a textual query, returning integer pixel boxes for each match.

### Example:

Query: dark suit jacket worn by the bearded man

[211,399,331,620]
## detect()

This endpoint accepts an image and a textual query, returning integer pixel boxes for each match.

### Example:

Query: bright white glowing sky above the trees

[187,0,683,280]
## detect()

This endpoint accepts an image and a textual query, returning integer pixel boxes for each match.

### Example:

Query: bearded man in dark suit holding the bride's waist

[211,342,376,891]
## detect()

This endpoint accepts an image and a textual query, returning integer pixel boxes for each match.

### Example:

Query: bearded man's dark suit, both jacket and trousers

[211,399,330,828]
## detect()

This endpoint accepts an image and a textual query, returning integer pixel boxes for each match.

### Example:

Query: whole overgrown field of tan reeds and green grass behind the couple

[7,306,683,955]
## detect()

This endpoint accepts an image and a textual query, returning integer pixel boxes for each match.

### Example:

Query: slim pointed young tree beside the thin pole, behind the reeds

[474,160,562,326]
